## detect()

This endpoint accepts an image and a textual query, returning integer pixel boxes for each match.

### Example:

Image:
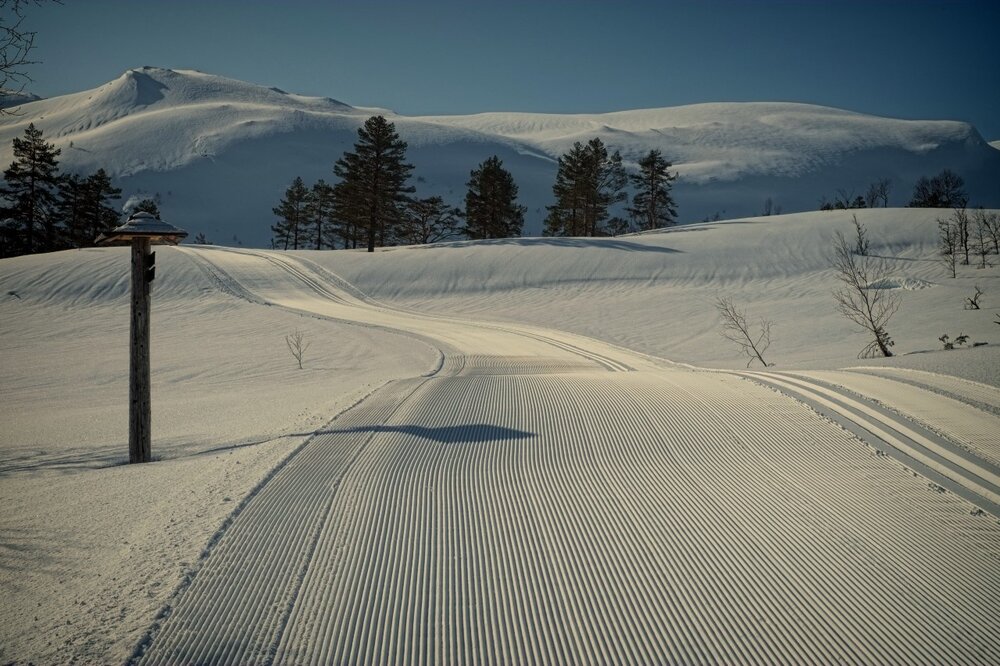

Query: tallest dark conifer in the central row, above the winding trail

[333,116,414,252]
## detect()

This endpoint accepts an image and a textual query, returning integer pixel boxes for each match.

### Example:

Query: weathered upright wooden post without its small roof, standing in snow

[128,238,150,463]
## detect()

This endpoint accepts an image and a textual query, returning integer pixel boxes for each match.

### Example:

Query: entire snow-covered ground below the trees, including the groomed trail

[0,209,1000,664]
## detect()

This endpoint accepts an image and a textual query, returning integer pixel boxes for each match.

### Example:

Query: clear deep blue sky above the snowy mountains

[26,0,1000,140]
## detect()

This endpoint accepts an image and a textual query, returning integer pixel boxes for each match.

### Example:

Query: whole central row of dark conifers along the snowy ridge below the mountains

[271,116,677,252]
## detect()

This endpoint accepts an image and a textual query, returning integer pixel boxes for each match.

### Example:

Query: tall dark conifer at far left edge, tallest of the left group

[0,123,61,254]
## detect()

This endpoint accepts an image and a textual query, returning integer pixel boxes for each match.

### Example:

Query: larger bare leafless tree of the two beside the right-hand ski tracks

[833,231,900,358]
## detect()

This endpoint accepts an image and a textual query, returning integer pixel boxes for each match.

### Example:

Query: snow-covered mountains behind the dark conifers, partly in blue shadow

[0,67,1000,247]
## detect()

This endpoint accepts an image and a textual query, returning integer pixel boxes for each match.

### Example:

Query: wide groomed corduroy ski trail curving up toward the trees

[135,252,1000,664]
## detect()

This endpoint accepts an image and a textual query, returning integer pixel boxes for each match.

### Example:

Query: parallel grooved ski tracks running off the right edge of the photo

[733,372,1000,516]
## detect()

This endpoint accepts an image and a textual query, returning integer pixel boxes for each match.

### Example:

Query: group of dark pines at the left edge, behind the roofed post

[0,123,121,257]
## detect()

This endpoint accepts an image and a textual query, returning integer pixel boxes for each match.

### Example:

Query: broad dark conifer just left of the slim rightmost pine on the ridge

[545,138,628,236]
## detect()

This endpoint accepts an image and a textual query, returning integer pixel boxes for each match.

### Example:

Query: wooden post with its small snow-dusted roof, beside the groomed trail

[96,211,187,463]
